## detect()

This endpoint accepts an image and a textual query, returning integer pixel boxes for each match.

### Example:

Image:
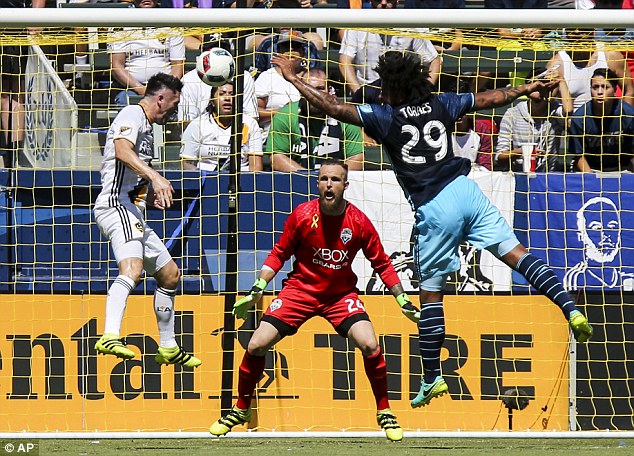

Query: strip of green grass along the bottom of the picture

[33,437,634,456]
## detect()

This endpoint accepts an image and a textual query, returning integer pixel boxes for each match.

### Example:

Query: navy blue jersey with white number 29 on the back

[357,93,475,209]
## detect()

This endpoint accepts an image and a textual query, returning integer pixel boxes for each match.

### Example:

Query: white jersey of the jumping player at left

[95,105,154,212]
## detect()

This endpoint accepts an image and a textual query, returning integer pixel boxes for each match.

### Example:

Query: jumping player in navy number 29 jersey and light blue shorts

[271,51,592,407]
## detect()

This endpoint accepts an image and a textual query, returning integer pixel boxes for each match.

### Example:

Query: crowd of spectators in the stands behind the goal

[0,0,634,172]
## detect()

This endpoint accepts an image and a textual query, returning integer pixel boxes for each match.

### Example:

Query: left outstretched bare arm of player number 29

[271,54,363,127]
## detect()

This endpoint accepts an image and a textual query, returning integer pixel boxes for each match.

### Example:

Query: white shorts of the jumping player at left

[95,206,172,275]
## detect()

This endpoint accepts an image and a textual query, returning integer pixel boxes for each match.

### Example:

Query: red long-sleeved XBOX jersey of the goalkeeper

[264,199,399,296]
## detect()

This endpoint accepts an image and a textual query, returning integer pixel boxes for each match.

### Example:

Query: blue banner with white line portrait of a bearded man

[515,173,634,291]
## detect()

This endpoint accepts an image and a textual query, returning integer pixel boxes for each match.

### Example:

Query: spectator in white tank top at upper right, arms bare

[547,28,634,115]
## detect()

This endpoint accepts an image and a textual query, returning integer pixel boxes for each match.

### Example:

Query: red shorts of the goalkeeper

[262,288,370,337]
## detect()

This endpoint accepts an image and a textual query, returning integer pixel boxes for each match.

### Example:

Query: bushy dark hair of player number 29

[375,51,434,102]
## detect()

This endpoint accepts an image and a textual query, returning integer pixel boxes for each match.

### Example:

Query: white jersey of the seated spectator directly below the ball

[180,112,262,171]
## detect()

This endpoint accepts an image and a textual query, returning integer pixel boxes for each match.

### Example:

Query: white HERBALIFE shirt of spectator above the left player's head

[108,28,185,84]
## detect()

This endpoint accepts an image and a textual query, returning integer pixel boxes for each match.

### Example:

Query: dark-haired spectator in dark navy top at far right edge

[569,68,634,173]
